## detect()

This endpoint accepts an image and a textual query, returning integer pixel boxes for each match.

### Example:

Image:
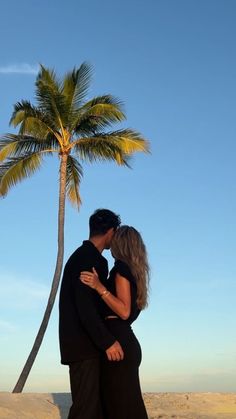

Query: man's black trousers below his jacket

[68,358,103,419]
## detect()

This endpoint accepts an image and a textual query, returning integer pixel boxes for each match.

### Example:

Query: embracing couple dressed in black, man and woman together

[59,209,149,419]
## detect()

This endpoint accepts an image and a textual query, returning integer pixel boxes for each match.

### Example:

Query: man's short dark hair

[89,209,121,237]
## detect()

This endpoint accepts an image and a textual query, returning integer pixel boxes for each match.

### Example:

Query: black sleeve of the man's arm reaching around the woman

[74,272,116,351]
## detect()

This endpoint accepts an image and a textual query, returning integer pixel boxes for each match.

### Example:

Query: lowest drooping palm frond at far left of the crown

[0,153,43,196]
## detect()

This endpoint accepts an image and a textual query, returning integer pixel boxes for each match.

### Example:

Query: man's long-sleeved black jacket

[59,240,115,364]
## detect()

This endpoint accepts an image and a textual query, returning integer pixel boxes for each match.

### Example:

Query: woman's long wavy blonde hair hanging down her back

[111,225,149,310]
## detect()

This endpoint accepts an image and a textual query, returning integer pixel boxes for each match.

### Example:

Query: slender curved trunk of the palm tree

[13,153,68,393]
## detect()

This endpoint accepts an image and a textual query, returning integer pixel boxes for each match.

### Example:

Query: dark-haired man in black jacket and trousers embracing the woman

[59,209,124,419]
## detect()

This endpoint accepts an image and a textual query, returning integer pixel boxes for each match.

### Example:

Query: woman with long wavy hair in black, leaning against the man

[80,226,149,419]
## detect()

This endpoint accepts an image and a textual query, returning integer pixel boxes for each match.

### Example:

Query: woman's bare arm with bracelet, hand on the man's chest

[80,269,131,320]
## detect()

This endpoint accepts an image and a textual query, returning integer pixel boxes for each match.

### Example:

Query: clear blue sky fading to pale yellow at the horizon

[0,0,236,392]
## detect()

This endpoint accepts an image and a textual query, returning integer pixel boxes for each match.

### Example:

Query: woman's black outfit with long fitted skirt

[101,260,148,419]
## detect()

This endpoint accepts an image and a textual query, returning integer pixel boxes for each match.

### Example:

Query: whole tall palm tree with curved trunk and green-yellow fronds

[0,63,148,393]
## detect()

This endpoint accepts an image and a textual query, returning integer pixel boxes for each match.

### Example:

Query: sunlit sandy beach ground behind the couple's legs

[0,392,236,419]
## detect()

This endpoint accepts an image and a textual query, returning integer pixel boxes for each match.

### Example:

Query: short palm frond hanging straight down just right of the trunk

[66,155,83,208]
